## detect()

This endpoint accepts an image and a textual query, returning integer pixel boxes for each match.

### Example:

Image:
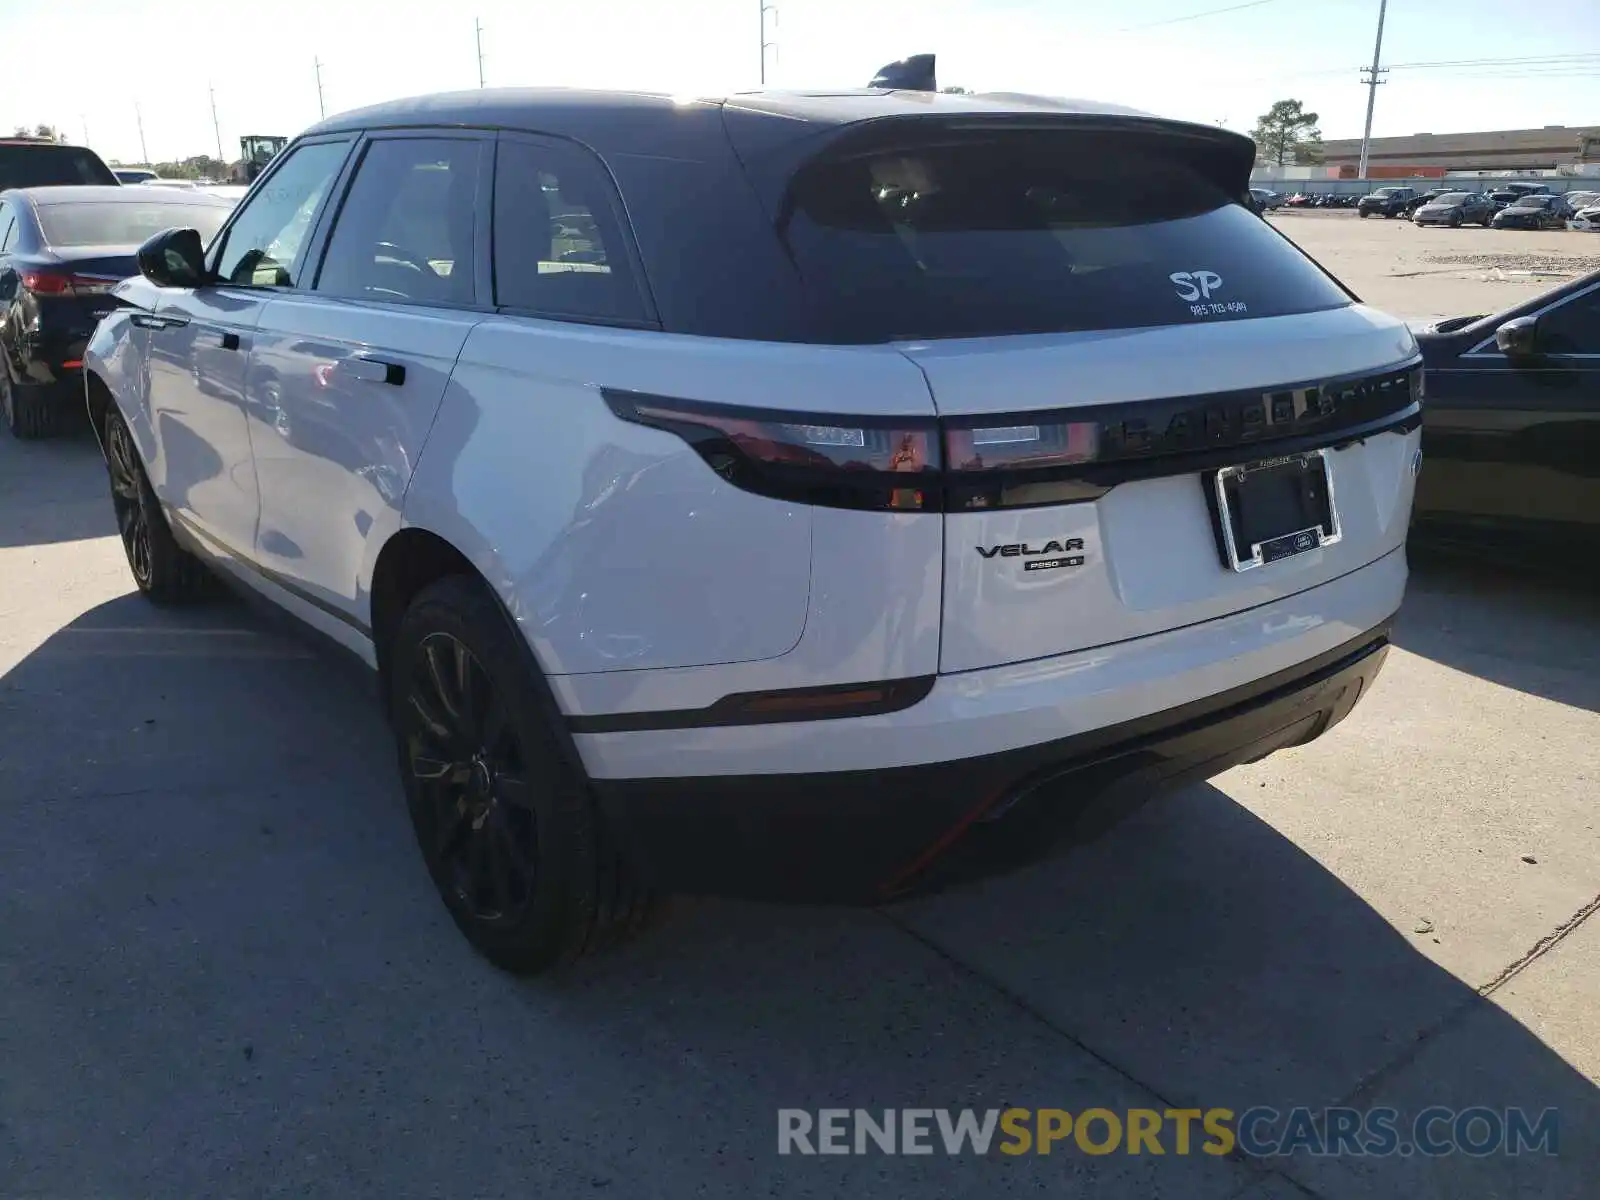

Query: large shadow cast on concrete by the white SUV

[0,597,1600,1200]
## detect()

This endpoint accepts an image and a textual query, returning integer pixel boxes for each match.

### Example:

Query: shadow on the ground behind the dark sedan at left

[0,419,117,549]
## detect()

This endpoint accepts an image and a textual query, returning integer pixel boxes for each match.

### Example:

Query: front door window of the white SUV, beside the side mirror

[216,142,350,288]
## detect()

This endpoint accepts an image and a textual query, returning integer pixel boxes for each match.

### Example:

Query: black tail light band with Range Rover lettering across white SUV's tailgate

[602,368,1422,512]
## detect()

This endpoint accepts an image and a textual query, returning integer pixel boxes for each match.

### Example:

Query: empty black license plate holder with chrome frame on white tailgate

[1213,450,1341,571]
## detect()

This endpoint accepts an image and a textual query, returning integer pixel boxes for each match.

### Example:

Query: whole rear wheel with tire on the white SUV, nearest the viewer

[387,576,654,974]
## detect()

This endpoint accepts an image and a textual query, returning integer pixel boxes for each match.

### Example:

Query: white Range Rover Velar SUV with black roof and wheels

[85,90,1421,970]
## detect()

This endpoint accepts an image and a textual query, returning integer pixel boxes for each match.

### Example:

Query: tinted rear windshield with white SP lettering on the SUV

[781,133,1350,341]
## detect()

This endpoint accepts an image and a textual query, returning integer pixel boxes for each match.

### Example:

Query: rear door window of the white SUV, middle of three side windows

[317,138,485,304]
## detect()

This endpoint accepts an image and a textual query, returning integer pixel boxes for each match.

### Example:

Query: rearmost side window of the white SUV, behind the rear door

[494,139,645,325]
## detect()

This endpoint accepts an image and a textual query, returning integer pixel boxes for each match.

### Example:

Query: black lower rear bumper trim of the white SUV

[594,622,1389,902]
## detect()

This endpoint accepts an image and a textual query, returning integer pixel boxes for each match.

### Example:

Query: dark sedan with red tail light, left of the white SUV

[0,186,232,438]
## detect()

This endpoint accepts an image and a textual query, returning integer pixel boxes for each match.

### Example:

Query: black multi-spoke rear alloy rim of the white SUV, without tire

[405,632,539,923]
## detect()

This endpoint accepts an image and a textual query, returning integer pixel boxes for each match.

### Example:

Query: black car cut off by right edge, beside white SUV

[1416,270,1600,579]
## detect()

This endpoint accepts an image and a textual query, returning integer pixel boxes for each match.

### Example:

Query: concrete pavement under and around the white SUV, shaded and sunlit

[0,412,1600,1200]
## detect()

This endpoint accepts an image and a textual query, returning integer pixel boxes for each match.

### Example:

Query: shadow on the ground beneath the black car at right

[1394,552,1600,712]
